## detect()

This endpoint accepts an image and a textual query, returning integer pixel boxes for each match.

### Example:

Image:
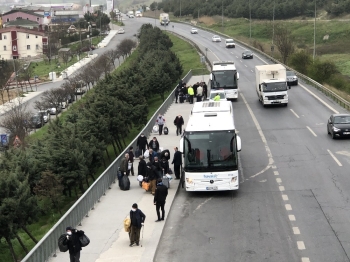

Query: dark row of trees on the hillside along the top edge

[154,0,332,19]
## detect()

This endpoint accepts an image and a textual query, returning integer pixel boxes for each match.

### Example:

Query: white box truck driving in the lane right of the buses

[255,64,288,106]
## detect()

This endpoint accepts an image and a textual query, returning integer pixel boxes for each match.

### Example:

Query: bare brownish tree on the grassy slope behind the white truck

[274,24,294,64]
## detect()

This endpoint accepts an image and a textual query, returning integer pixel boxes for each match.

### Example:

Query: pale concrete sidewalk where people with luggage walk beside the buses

[49,76,208,262]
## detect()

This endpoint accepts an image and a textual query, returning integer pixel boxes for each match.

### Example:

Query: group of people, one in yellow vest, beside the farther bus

[175,80,208,104]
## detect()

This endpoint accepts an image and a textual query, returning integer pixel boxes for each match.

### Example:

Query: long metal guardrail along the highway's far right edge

[178,21,350,110]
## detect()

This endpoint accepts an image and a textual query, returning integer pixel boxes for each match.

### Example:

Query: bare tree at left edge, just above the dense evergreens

[0,97,31,141]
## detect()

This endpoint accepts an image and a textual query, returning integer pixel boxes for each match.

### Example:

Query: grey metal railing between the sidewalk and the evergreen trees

[22,71,192,262]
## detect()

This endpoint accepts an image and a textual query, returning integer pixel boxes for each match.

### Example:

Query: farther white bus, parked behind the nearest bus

[208,61,239,100]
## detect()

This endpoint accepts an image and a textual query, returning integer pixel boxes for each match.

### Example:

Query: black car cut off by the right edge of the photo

[327,114,350,139]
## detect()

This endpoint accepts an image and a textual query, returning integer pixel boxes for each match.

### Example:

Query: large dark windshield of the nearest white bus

[184,130,238,172]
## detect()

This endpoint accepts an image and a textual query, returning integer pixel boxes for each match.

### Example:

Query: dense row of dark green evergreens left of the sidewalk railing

[0,24,182,261]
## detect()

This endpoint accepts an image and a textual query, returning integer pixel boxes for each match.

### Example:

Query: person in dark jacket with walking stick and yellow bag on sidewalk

[129,203,146,247]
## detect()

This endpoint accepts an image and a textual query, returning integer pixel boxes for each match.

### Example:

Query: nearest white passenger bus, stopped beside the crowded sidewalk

[180,101,241,191]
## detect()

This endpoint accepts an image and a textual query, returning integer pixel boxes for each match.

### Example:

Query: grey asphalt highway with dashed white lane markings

[122,18,350,262]
